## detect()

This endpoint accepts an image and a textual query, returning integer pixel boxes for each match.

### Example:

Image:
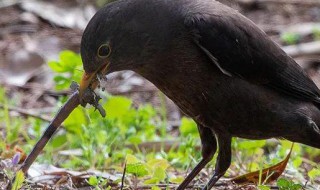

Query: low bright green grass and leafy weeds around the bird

[0,51,320,189]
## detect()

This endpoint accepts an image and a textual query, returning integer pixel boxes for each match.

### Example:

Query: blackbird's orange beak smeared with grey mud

[79,64,109,100]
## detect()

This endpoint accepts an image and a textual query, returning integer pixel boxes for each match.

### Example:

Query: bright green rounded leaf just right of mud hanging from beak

[105,96,132,119]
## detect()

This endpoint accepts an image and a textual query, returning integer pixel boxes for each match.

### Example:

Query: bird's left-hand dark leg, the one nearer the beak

[177,125,217,190]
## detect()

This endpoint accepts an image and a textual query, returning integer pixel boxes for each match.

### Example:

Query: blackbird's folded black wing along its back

[185,13,320,103]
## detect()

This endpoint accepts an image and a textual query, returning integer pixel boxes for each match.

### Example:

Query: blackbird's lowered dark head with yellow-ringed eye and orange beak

[79,1,161,99]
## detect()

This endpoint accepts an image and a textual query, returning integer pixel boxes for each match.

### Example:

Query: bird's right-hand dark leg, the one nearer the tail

[202,134,231,190]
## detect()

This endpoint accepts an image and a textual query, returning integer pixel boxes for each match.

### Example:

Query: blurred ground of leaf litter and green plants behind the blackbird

[0,0,320,189]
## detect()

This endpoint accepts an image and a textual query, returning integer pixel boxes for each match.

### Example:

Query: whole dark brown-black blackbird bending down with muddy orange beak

[79,0,320,189]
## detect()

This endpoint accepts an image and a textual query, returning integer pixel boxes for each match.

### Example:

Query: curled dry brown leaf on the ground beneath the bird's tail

[231,143,294,185]
